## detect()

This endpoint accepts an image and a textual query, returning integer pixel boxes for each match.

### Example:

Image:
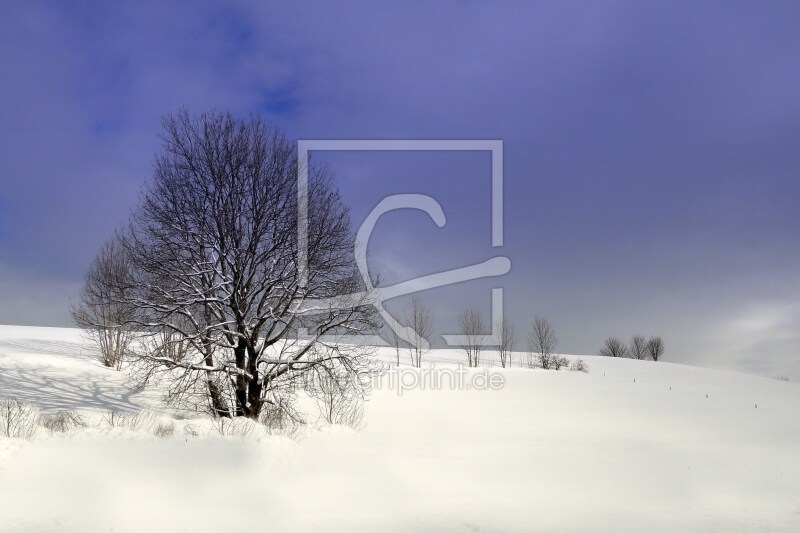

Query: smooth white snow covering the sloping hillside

[0,326,800,532]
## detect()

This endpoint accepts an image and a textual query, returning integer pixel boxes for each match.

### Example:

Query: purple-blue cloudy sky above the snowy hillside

[0,0,800,380]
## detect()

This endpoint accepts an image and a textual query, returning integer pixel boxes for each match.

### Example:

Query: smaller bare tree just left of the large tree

[72,239,136,369]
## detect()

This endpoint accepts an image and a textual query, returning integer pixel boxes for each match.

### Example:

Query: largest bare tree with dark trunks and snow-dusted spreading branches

[96,112,376,419]
